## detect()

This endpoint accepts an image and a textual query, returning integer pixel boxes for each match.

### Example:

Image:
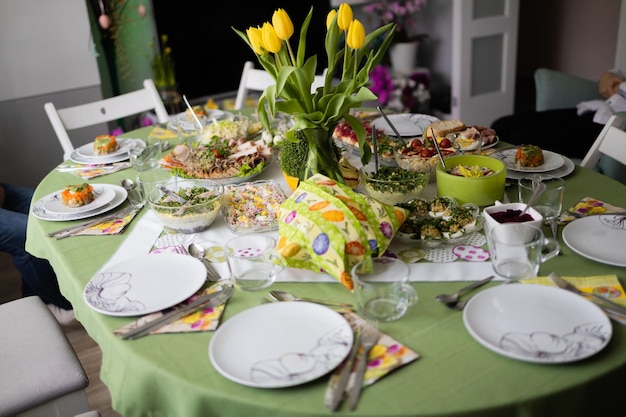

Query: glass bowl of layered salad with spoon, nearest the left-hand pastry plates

[147,177,224,233]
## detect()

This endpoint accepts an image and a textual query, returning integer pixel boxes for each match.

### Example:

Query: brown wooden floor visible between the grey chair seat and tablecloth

[0,252,121,417]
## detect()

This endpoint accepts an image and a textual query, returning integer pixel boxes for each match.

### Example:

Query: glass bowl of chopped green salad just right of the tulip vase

[359,165,430,205]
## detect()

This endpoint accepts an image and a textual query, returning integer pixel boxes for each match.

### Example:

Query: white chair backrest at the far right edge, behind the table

[580,115,626,168]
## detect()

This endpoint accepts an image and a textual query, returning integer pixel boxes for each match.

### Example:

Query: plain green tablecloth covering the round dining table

[26,128,626,417]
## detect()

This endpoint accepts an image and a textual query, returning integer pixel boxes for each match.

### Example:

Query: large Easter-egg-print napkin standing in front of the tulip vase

[277,174,408,290]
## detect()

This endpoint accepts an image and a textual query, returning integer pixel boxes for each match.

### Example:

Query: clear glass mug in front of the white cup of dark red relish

[487,223,561,281]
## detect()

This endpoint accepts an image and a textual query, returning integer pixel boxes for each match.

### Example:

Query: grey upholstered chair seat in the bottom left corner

[0,296,91,417]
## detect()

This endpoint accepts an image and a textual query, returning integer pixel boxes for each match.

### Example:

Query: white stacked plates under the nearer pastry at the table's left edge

[32,184,128,222]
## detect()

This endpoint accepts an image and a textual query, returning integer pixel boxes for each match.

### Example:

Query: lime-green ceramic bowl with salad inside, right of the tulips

[435,155,506,207]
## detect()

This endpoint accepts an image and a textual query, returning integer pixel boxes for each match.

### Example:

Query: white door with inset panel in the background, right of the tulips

[451,0,519,126]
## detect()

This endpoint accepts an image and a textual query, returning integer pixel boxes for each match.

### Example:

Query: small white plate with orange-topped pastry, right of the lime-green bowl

[492,145,565,173]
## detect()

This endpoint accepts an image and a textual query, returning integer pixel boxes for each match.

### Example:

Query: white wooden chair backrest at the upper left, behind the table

[44,79,169,159]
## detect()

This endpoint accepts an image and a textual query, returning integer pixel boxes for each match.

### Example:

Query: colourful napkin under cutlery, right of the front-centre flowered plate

[331,313,420,390]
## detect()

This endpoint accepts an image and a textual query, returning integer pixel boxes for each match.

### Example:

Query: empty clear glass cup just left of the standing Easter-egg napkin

[225,234,285,291]
